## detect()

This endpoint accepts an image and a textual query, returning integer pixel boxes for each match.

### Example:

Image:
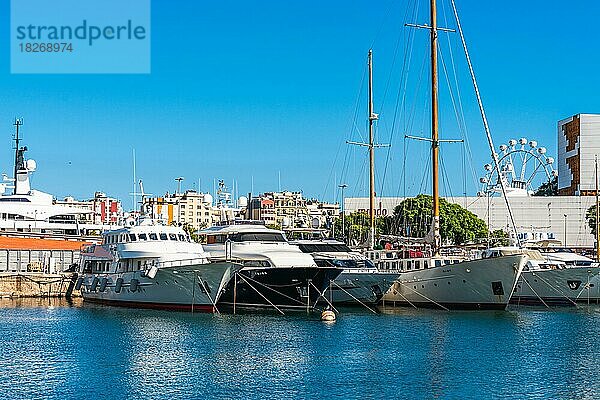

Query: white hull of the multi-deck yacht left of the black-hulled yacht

[81,262,241,312]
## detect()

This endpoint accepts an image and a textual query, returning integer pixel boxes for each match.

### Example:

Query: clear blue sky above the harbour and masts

[0,0,600,211]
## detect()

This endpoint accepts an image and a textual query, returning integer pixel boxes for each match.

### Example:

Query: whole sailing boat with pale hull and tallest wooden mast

[367,0,527,309]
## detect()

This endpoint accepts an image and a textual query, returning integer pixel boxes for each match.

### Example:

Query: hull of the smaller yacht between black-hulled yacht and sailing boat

[324,269,398,306]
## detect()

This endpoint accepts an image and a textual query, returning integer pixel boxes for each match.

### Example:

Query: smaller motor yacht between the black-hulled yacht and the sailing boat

[290,239,398,305]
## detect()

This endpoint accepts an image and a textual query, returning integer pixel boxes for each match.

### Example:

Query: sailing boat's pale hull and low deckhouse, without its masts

[367,249,527,309]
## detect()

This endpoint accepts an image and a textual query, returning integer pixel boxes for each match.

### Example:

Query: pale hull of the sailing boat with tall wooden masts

[383,255,527,310]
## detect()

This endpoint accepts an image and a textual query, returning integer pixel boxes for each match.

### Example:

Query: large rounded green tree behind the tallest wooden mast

[385,194,488,245]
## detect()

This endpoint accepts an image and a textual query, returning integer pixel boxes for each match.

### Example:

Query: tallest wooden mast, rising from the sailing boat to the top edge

[430,0,442,254]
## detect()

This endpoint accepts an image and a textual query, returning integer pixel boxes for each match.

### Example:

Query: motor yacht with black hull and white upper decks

[199,221,342,310]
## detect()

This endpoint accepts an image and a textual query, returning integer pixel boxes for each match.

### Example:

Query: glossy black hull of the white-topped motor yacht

[218,267,342,310]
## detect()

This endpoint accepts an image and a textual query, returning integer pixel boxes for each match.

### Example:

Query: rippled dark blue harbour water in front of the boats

[0,300,600,399]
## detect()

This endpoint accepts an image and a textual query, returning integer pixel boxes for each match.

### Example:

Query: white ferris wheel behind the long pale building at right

[479,138,558,196]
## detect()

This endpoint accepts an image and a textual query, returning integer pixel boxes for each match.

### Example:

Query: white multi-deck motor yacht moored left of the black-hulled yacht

[75,218,241,312]
